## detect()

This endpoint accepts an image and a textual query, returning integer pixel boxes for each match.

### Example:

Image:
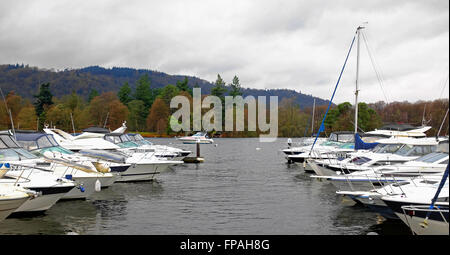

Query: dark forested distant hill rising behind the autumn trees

[0,64,328,109]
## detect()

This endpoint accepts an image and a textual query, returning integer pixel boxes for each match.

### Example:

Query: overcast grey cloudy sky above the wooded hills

[0,0,449,103]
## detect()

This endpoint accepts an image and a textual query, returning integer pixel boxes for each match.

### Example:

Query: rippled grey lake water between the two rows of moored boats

[0,138,410,235]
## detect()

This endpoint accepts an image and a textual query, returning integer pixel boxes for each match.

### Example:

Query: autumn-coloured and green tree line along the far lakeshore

[0,74,449,137]
